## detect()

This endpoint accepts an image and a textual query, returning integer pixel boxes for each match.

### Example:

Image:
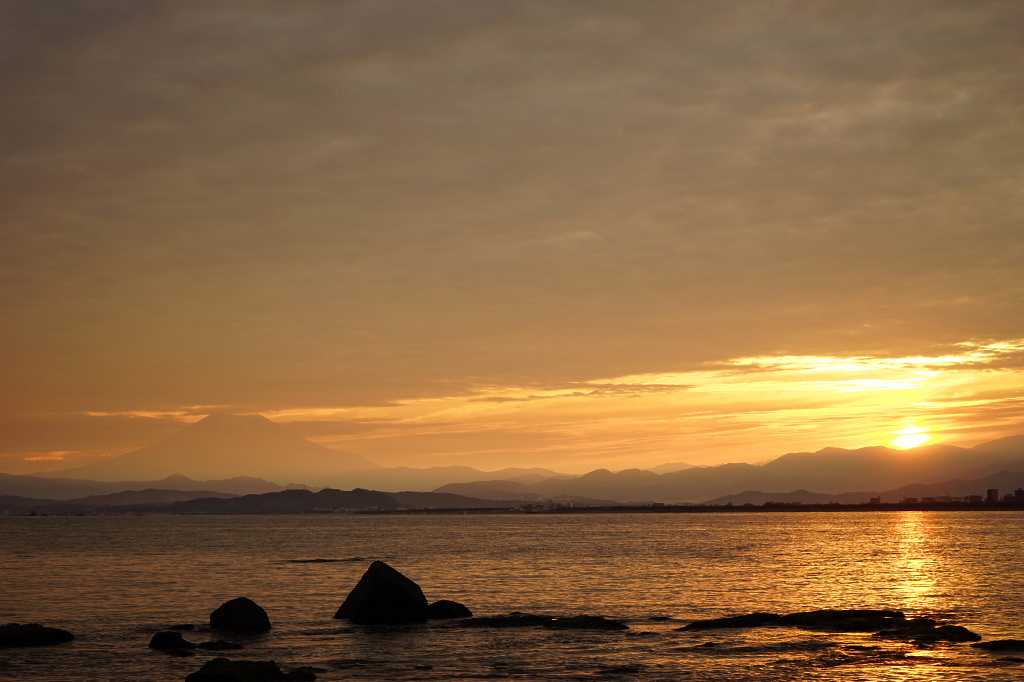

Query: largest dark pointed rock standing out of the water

[334,561,428,625]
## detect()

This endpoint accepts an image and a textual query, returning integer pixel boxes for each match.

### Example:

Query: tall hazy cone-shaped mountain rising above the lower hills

[38,415,377,483]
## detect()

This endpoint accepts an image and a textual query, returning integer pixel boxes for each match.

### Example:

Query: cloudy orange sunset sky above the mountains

[0,0,1024,473]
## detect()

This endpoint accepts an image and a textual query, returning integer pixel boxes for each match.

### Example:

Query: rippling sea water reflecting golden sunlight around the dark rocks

[0,512,1024,681]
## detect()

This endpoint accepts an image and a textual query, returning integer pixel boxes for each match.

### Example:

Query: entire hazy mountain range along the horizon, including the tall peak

[8,415,1024,504]
